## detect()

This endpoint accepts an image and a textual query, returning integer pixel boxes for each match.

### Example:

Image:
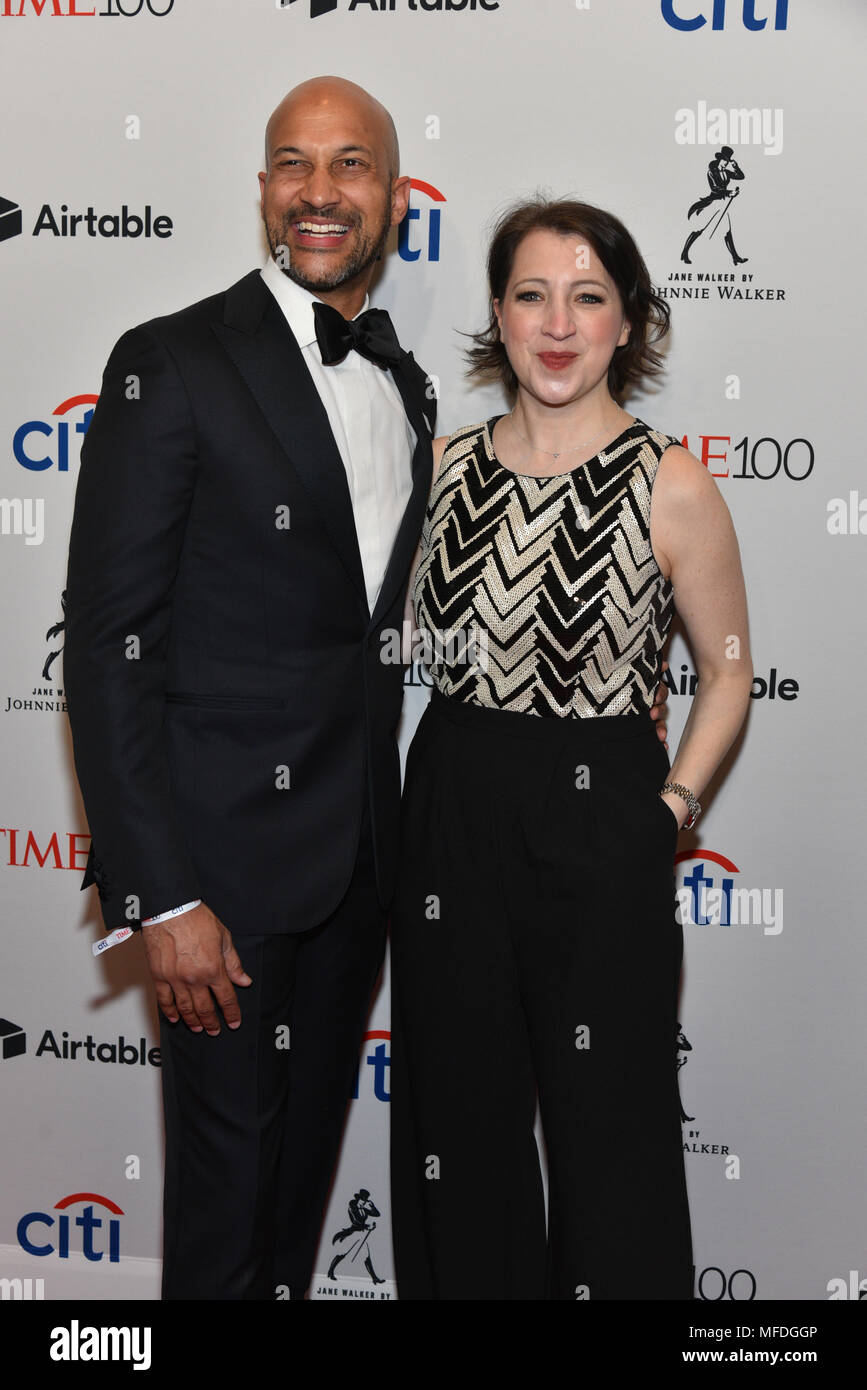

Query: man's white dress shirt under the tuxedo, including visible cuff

[143,256,417,926]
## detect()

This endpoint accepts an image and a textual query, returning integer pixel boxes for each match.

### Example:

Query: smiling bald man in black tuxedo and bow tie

[65,78,435,1300]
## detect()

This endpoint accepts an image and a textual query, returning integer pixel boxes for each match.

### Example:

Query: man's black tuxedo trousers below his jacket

[160,813,386,1300]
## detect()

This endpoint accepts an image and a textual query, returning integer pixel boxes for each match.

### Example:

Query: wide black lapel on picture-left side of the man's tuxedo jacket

[213,271,368,612]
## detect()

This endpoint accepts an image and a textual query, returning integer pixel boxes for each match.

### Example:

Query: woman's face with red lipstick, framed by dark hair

[493,229,629,406]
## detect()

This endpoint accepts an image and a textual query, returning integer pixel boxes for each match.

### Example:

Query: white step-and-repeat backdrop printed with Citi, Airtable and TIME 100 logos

[0,0,867,1300]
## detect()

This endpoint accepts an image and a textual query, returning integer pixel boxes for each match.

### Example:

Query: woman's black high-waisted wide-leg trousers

[392,691,692,1300]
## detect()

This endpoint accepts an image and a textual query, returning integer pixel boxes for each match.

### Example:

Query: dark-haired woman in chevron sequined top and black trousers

[392,199,752,1300]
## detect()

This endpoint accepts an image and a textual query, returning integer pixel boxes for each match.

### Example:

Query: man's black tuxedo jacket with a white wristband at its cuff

[64,262,436,931]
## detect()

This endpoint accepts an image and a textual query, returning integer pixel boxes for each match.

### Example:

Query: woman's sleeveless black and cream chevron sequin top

[414,416,681,719]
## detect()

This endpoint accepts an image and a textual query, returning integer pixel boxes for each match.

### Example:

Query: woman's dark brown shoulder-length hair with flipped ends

[467,193,670,399]
